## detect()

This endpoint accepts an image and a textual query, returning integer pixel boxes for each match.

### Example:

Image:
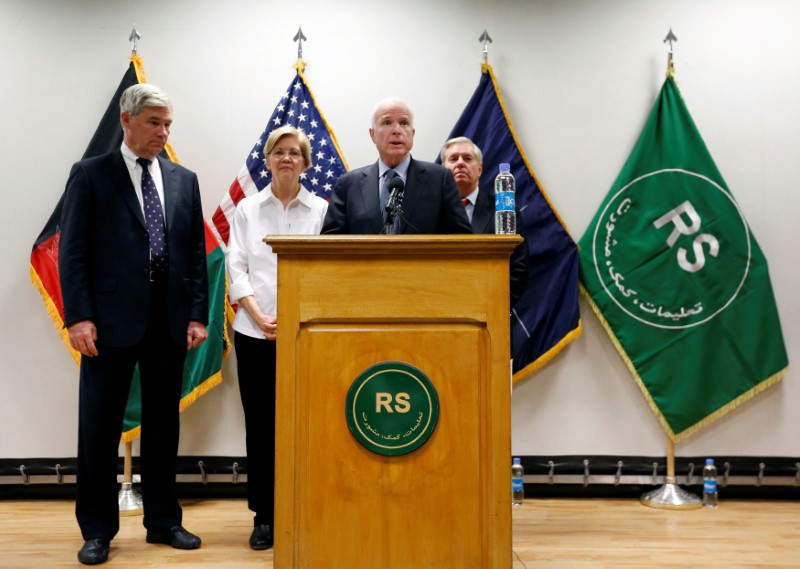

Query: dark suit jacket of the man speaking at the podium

[322,158,472,234]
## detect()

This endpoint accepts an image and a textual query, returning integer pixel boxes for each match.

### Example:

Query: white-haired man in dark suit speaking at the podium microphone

[322,98,472,234]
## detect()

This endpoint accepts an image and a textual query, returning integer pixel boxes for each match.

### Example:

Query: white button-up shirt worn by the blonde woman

[225,184,328,339]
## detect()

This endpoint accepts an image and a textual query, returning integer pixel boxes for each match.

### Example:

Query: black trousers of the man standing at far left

[75,284,186,540]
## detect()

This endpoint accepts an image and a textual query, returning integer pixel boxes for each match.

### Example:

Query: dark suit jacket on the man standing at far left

[58,150,208,346]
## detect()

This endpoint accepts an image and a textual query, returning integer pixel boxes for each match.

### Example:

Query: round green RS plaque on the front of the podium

[345,361,439,456]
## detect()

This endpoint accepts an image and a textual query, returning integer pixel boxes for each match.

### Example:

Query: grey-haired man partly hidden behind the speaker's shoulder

[440,136,528,307]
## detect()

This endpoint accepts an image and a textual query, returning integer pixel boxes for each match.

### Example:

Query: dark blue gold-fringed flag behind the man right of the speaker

[449,64,582,381]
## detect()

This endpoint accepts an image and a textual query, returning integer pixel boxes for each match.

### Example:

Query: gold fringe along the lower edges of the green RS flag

[579,283,789,443]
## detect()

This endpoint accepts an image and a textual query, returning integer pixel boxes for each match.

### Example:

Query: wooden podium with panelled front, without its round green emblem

[265,235,520,569]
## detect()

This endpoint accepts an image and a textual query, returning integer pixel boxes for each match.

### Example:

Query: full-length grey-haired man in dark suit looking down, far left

[59,84,208,565]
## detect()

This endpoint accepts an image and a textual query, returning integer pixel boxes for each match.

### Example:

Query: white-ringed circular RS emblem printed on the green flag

[592,169,751,329]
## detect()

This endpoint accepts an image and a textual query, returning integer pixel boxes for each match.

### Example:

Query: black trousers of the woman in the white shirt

[233,332,275,526]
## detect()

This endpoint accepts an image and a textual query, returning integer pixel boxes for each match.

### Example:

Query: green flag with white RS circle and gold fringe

[580,73,788,442]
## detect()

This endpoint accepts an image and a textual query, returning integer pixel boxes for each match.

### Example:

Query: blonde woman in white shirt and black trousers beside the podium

[225,126,328,549]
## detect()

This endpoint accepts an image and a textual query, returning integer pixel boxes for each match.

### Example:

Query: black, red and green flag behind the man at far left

[30,55,230,442]
